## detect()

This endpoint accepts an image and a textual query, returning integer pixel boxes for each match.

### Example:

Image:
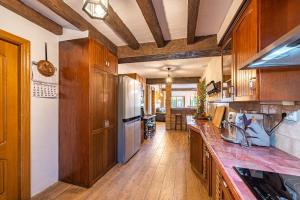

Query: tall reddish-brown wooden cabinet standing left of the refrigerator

[59,38,118,187]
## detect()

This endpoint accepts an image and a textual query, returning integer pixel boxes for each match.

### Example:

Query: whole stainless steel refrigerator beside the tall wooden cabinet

[118,75,142,163]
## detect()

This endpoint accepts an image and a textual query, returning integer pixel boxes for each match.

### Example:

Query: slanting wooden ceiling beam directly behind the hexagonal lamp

[104,5,140,50]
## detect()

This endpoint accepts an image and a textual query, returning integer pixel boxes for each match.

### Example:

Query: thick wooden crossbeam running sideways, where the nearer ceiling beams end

[118,35,221,63]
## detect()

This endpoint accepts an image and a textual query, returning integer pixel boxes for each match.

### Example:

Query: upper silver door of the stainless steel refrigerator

[123,76,135,119]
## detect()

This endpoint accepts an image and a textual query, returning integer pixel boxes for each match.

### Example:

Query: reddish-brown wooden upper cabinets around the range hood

[232,0,300,101]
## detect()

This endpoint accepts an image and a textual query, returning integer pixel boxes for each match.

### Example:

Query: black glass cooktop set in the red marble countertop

[234,167,300,200]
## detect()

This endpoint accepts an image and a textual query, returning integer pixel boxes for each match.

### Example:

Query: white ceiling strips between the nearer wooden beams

[22,0,233,46]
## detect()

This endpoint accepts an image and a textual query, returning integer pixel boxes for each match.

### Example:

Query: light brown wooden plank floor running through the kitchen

[33,123,208,200]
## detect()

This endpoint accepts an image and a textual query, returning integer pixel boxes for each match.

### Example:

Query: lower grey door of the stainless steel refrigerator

[123,121,135,162]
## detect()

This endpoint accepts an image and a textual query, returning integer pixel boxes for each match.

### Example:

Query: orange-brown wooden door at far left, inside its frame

[0,40,20,200]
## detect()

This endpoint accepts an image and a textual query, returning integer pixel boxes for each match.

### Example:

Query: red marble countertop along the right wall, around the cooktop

[188,121,300,200]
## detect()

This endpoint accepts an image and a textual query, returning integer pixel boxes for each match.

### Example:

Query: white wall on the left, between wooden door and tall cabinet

[0,6,84,196]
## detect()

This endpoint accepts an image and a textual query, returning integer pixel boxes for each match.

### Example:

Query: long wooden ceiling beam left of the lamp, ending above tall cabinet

[38,0,117,54]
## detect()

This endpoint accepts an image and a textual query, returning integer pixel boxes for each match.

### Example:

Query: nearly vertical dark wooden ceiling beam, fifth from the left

[187,0,200,44]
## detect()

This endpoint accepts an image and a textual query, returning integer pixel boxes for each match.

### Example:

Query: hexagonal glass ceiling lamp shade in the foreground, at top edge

[82,0,108,19]
